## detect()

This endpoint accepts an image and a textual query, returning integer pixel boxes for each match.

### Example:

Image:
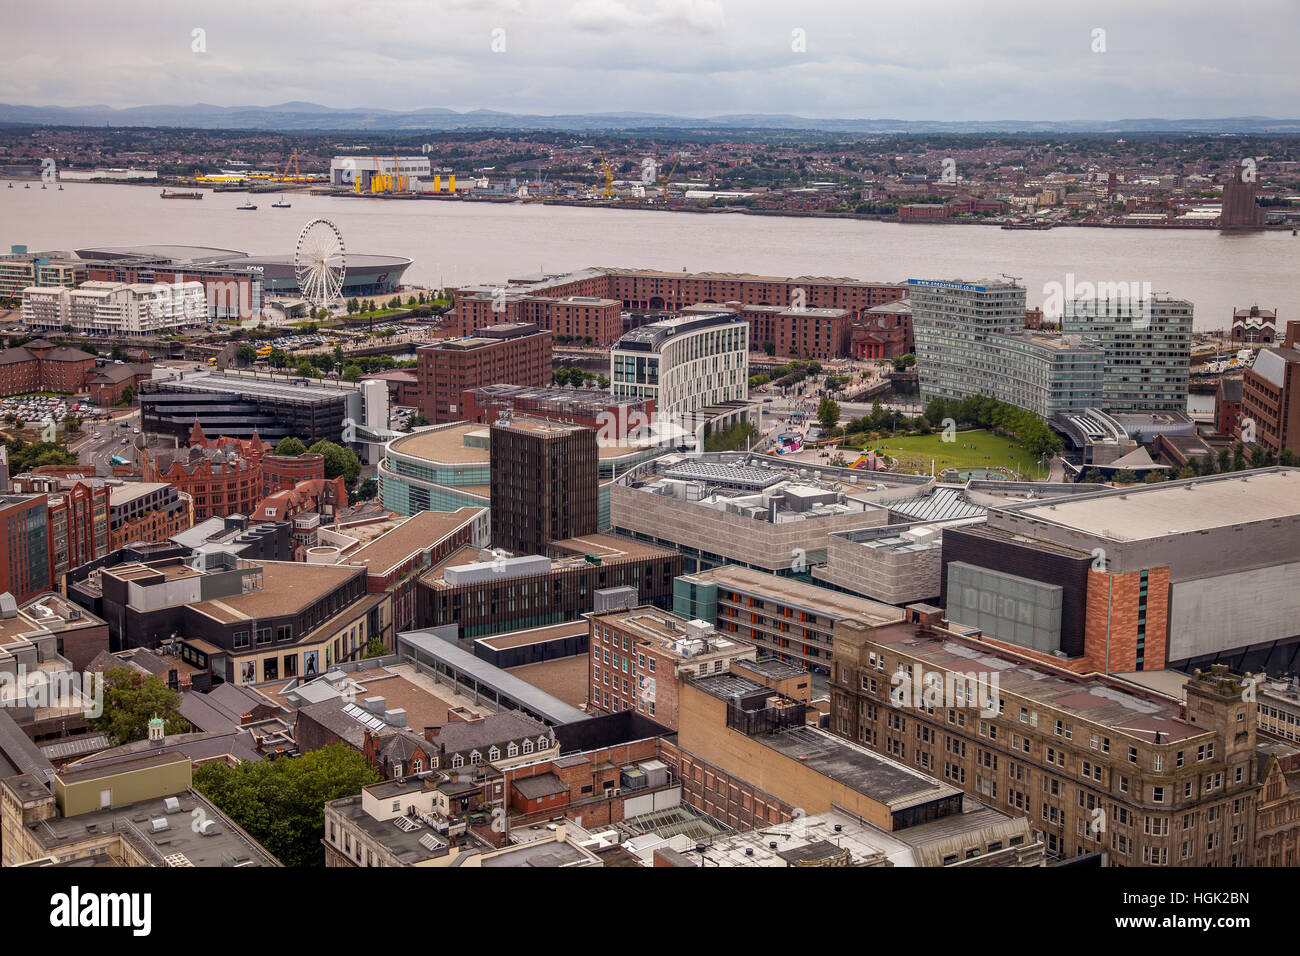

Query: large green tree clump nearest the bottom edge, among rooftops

[194,744,380,866]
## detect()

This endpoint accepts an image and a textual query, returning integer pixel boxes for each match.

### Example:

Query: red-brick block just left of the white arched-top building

[416,323,554,425]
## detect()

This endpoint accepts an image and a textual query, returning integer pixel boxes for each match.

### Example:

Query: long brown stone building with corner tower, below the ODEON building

[832,607,1260,866]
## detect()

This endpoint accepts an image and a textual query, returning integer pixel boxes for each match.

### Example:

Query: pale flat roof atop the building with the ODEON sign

[997,468,1300,541]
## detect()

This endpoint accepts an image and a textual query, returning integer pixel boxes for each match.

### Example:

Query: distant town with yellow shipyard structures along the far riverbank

[0,126,1300,229]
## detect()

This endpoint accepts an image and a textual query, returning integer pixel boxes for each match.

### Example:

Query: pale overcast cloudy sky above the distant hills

[10,0,1300,120]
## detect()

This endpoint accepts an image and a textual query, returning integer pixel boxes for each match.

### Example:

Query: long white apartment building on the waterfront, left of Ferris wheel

[22,281,208,336]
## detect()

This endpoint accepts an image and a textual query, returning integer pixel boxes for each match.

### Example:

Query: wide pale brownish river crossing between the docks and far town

[0,182,1300,329]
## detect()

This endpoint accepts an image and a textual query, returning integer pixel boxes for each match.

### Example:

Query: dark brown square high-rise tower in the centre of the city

[489,418,599,554]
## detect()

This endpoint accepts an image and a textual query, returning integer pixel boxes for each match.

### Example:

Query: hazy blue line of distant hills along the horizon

[0,103,1300,134]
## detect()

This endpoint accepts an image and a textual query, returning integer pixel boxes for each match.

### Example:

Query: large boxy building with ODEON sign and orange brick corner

[940,467,1300,674]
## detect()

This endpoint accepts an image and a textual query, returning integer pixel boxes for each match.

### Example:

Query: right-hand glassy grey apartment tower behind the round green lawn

[1061,293,1192,411]
